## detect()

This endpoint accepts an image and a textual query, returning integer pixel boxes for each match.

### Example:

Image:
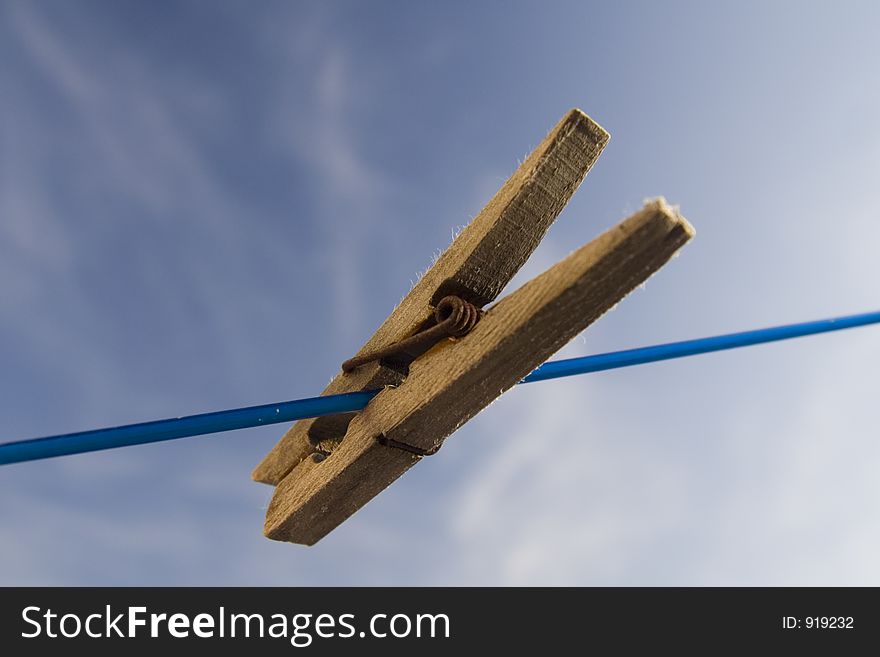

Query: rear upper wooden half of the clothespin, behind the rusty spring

[252,109,609,485]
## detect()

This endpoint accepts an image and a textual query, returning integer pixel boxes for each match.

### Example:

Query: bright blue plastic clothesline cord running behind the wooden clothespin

[0,311,880,465]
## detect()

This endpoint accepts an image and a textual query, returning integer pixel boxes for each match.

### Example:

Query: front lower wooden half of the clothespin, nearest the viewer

[264,199,694,545]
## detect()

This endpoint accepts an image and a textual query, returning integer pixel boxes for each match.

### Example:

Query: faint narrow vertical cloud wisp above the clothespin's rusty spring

[271,25,395,344]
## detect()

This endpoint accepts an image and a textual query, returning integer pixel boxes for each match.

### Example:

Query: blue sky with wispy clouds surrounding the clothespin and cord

[0,1,880,585]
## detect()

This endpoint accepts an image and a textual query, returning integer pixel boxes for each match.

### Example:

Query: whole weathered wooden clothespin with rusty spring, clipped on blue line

[253,109,694,545]
